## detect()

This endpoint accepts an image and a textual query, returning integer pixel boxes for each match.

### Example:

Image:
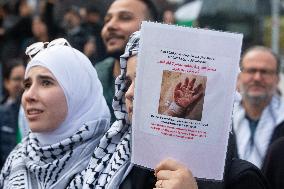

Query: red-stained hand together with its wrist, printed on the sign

[164,78,203,117]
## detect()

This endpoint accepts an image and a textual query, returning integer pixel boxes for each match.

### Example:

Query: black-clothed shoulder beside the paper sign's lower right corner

[225,158,269,189]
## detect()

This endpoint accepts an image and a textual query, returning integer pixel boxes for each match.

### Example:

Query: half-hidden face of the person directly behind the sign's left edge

[125,56,137,122]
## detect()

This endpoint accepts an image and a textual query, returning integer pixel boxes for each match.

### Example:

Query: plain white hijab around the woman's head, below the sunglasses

[25,45,110,145]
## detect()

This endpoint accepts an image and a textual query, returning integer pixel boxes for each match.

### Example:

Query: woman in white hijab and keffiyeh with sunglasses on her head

[0,39,110,188]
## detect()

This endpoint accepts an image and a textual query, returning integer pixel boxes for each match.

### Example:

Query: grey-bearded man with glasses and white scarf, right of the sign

[233,46,284,168]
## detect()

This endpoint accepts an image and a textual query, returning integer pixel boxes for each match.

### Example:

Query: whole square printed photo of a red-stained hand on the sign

[158,71,206,121]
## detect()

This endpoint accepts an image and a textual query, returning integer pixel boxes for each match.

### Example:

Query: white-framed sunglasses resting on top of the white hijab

[25,38,71,59]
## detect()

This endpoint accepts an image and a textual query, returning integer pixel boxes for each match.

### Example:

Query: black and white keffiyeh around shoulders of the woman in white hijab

[0,120,108,189]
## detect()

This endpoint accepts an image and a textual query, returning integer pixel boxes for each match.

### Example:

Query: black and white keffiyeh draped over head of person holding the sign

[75,32,140,189]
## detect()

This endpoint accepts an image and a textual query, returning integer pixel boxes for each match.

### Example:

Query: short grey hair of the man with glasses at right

[240,45,281,74]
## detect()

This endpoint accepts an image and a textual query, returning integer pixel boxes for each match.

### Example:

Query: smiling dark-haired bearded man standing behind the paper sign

[95,0,158,122]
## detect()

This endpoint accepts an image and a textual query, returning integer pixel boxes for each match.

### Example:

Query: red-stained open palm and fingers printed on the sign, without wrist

[173,77,203,109]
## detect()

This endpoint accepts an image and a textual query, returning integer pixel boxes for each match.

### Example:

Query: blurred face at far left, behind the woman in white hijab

[4,65,25,98]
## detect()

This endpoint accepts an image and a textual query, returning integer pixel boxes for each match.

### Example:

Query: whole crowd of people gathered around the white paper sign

[0,0,284,189]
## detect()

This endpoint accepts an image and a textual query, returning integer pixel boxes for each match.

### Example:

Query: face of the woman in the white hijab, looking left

[22,66,68,133]
